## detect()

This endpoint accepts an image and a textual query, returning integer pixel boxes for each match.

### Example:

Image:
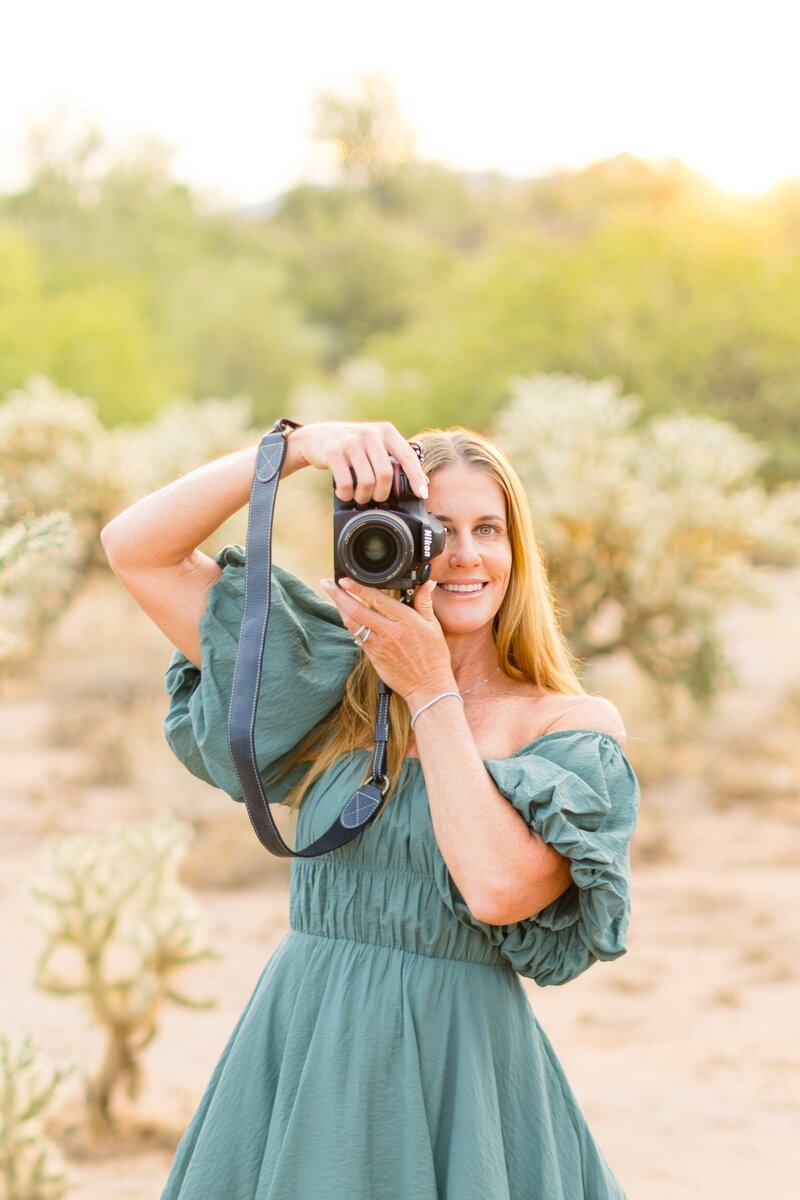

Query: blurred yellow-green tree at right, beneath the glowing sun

[359,180,800,482]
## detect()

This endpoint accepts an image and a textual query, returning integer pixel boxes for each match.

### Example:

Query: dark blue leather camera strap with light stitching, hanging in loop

[228,419,392,858]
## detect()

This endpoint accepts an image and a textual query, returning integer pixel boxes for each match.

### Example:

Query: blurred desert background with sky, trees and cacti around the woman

[0,0,800,1200]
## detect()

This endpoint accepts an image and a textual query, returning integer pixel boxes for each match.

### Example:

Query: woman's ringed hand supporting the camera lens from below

[320,576,456,708]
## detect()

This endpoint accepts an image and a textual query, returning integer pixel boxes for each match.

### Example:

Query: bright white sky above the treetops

[0,0,800,204]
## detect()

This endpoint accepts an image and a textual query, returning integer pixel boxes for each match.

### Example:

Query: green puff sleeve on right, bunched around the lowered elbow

[434,730,639,986]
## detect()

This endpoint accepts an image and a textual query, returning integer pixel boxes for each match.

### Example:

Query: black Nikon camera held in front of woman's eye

[333,455,447,592]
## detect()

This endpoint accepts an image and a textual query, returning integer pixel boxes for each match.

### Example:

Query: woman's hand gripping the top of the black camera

[289,421,428,504]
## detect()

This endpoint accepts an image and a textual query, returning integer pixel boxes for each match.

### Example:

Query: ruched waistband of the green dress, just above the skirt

[289,856,510,967]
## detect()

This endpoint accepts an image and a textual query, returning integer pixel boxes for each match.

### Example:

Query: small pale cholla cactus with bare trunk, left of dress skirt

[31,817,217,1128]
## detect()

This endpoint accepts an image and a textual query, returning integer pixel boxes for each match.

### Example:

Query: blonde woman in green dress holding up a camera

[103,421,638,1200]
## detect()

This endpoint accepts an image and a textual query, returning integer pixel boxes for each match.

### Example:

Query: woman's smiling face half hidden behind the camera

[426,467,511,634]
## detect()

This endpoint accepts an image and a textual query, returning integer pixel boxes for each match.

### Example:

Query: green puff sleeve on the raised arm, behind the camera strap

[164,545,359,803]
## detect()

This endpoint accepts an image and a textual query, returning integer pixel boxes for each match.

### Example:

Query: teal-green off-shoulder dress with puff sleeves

[162,546,638,1200]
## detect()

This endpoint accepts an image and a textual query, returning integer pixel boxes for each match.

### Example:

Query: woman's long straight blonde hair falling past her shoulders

[267,425,584,808]
